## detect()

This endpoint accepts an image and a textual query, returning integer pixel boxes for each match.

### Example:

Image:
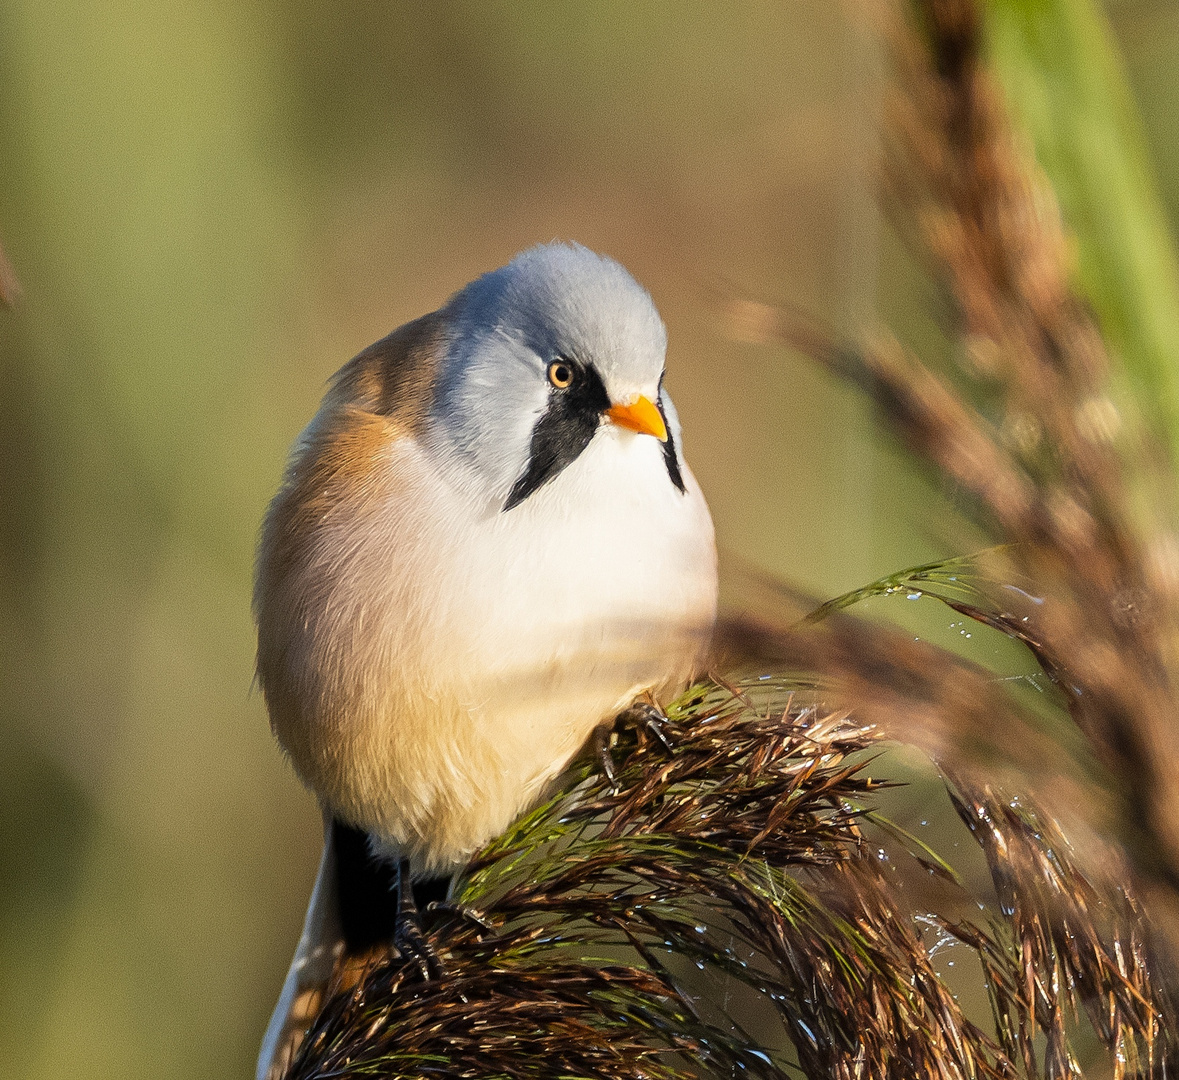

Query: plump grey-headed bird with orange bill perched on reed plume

[253,242,717,1080]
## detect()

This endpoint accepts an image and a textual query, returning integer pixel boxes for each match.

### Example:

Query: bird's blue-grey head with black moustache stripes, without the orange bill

[430,243,684,511]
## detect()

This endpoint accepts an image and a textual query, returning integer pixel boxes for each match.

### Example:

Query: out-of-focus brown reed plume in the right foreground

[721,0,1179,941]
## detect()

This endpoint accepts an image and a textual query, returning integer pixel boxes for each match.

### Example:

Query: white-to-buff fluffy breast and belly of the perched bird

[275,424,716,872]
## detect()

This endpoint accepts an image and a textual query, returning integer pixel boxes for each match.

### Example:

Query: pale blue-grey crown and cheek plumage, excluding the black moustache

[430,243,679,501]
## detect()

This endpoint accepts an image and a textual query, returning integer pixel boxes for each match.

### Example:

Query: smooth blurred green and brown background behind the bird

[0,0,1179,1080]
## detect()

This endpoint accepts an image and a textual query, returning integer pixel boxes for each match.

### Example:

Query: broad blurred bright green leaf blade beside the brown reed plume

[986,0,1179,461]
